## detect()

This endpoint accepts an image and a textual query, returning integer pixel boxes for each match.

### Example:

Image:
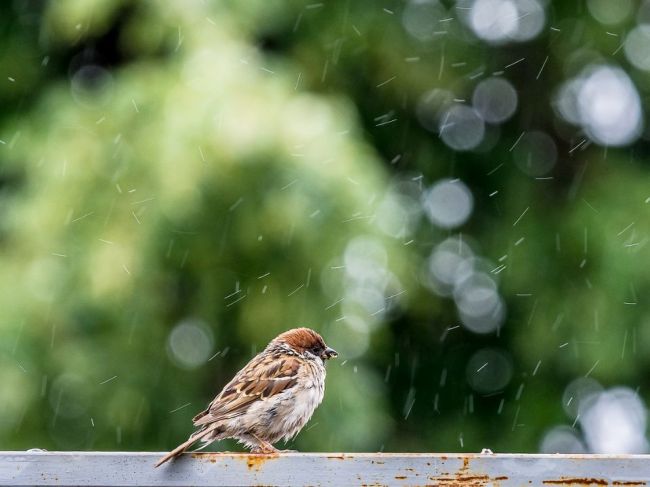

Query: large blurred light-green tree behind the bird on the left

[2,0,404,449]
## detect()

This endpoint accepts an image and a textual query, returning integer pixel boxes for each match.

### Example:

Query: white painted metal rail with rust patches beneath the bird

[0,452,650,487]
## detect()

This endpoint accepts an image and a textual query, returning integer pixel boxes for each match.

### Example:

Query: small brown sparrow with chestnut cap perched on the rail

[156,328,338,467]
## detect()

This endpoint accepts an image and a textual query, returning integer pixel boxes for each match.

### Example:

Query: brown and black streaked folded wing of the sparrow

[193,354,302,426]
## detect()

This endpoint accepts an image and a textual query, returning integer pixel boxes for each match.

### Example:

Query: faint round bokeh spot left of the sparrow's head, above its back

[167,319,214,369]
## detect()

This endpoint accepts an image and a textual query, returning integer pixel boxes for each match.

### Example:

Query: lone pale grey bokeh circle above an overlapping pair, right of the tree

[422,179,474,228]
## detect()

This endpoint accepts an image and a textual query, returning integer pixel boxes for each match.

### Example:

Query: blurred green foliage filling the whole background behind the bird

[0,0,650,451]
